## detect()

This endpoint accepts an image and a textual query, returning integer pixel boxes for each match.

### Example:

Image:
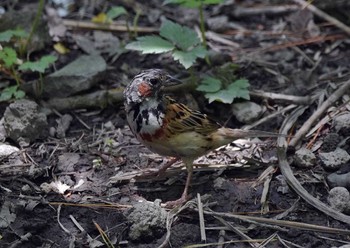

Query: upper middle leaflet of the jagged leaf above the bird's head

[159,20,200,51]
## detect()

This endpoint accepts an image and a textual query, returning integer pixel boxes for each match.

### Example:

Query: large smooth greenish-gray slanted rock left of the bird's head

[23,55,107,97]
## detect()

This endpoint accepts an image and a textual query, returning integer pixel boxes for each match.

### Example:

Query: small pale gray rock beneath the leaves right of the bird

[232,101,265,123]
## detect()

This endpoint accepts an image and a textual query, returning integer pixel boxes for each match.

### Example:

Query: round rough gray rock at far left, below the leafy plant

[4,99,49,143]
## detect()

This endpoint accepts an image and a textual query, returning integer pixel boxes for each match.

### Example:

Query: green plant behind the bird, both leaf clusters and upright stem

[126,0,249,103]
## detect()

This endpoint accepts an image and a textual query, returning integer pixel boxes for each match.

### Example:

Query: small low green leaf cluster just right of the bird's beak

[197,64,250,103]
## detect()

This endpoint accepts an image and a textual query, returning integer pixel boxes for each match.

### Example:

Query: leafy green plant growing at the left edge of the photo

[0,30,57,101]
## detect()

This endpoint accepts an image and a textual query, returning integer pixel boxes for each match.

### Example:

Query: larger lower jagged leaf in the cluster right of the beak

[205,79,250,103]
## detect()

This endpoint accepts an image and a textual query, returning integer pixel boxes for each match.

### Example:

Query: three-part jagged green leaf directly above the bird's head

[126,20,207,69]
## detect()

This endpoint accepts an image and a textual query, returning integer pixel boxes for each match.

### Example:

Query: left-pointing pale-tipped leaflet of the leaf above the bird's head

[125,36,175,54]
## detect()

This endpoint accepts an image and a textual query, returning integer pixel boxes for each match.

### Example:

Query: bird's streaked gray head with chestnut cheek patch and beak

[124,69,181,104]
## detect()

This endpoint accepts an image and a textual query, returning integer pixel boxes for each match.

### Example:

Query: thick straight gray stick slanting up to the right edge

[289,80,350,146]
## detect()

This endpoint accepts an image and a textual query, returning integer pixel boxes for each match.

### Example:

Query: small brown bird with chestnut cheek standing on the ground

[123,69,279,208]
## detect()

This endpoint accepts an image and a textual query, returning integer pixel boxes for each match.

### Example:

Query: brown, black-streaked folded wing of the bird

[165,97,221,135]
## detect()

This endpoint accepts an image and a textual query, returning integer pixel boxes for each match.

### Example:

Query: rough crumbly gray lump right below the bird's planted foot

[127,201,167,240]
